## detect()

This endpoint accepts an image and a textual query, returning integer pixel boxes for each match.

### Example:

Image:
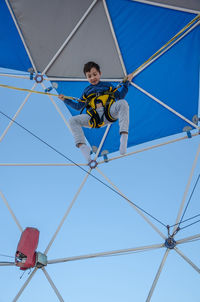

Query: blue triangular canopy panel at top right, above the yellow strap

[107,0,196,73]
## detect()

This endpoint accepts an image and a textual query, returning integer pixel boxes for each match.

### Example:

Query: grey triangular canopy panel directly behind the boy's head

[47,1,124,79]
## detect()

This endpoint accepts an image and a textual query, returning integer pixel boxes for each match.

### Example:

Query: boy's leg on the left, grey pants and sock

[69,114,91,163]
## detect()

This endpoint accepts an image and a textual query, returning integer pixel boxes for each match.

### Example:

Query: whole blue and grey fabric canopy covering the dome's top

[0,0,200,153]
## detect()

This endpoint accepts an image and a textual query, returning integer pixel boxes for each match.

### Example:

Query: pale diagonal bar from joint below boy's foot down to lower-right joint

[96,167,167,240]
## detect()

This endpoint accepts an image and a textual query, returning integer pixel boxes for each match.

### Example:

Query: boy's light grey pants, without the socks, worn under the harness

[69,100,129,146]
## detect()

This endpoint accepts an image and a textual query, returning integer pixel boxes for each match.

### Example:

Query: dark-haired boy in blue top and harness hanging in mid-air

[58,62,133,164]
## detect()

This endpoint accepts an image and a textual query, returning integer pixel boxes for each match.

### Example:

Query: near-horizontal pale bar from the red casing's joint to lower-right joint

[48,244,164,264]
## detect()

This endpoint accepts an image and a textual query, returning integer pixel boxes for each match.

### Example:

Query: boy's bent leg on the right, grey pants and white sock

[110,100,129,155]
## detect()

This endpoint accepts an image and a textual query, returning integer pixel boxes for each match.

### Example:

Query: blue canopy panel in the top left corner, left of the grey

[0,1,32,72]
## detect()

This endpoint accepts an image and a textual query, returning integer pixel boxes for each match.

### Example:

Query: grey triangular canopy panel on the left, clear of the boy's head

[10,0,92,72]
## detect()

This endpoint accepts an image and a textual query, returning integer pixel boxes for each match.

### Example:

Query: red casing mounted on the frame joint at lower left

[15,227,39,270]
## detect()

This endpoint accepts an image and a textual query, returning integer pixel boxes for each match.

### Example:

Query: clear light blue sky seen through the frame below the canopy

[0,70,200,302]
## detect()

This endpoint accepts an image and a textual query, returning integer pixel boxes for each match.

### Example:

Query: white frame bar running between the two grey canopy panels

[42,0,98,74]
